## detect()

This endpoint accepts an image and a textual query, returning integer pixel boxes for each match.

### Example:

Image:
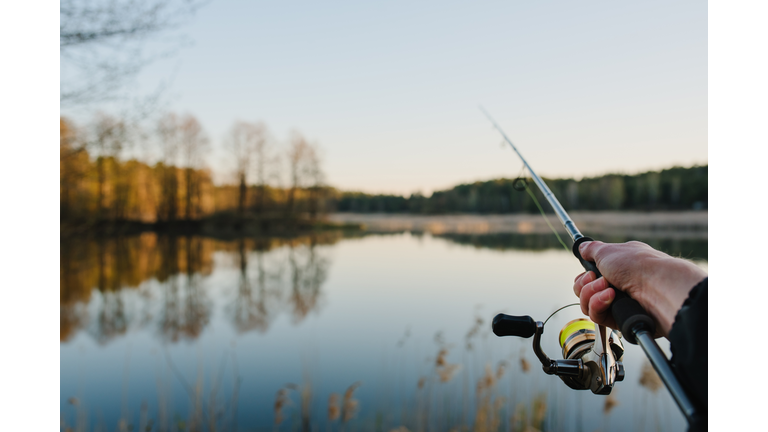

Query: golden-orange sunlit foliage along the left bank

[59,115,334,223]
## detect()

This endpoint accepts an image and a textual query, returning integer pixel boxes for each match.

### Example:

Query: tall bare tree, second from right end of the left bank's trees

[227,121,267,217]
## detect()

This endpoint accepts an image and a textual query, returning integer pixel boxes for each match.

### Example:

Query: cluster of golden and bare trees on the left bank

[60,114,330,224]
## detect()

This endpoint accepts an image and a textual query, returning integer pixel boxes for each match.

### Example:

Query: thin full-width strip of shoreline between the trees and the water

[60,210,708,240]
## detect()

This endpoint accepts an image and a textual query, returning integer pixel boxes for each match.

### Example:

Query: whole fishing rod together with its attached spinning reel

[480,107,701,425]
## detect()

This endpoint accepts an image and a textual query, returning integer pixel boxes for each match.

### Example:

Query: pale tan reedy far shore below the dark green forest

[327,210,708,239]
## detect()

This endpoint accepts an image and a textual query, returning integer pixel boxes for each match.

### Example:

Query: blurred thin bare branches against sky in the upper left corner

[59,0,203,105]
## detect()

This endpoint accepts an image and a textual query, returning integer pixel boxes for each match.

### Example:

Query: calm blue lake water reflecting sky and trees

[60,224,707,432]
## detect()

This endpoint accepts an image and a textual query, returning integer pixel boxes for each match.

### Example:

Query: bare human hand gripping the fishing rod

[573,241,707,337]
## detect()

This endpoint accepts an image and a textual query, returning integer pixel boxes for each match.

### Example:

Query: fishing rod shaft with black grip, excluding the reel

[480,106,700,424]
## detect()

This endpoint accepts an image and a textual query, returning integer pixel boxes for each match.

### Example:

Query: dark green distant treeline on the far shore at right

[335,165,708,214]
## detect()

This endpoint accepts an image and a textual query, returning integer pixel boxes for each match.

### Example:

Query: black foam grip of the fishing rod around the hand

[573,237,656,345]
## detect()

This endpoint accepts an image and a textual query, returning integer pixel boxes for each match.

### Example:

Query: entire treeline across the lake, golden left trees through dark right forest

[60,113,708,227]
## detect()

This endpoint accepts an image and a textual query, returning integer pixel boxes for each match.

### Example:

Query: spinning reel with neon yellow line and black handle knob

[493,314,624,395]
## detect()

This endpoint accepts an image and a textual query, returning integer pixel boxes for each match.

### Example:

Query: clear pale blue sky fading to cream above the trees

[87,0,708,194]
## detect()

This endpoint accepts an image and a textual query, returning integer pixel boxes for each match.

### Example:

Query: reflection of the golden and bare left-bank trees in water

[60,233,341,343]
